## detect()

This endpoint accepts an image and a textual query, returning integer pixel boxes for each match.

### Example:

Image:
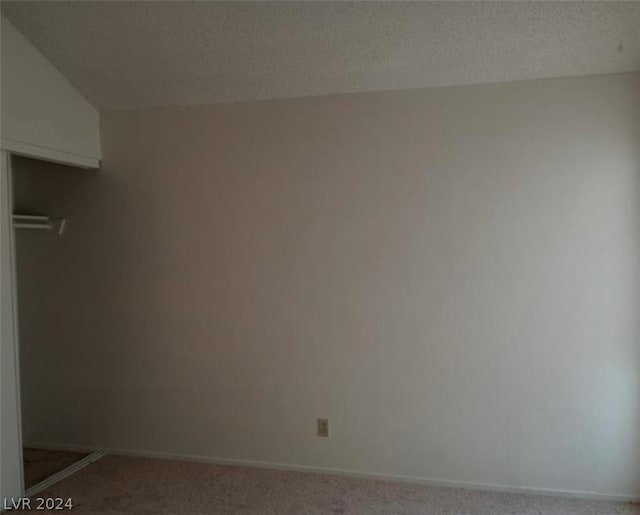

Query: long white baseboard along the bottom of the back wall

[29,442,640,502]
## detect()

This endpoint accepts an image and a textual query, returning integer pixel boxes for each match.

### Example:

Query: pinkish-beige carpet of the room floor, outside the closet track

[27,456,640,515]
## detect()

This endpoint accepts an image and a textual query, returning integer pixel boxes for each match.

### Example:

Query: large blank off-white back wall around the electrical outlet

[16,74,640,496]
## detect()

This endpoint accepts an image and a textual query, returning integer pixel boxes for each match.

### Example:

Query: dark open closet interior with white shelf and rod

[11,156,102,495]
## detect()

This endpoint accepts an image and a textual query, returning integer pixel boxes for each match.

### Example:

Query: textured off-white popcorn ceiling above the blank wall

[1,1,640,109]
